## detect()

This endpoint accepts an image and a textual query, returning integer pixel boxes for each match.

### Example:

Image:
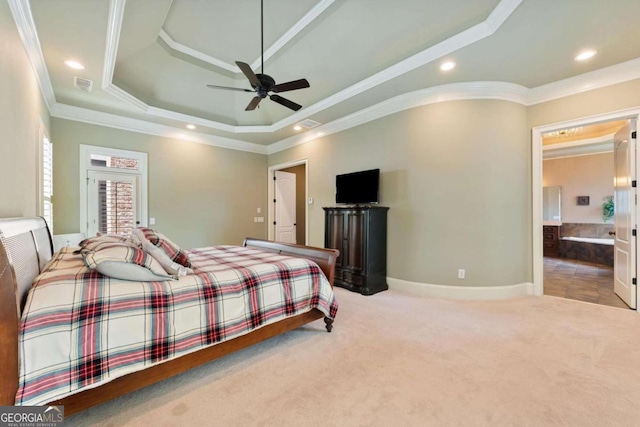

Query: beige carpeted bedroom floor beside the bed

[66,289,640,426]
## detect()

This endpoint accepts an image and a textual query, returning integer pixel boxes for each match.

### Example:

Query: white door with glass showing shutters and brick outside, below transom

[87,170,140,236]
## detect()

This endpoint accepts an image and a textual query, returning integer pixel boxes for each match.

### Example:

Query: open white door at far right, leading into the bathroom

[613,123,636,308]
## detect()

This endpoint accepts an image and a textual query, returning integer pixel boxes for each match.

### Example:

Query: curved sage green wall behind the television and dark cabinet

[269,100,532,286]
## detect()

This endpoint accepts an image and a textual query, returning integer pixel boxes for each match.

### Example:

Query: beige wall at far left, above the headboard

[0,1,49,217]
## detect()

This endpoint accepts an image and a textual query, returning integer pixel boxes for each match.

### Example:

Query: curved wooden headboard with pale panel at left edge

[0,218,53,406]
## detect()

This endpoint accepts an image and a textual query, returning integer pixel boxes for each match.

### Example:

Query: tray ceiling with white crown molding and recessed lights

[9,0,640,152]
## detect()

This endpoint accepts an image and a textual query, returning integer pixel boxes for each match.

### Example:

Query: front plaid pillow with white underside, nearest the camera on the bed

[82,242,174,282]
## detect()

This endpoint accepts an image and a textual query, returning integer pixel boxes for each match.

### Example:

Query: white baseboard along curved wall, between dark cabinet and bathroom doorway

[387,277,533,300]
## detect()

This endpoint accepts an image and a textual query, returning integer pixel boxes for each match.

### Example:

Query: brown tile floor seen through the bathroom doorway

[544,257,629,309]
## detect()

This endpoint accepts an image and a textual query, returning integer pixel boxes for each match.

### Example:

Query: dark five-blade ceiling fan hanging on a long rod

[207,0,310,111]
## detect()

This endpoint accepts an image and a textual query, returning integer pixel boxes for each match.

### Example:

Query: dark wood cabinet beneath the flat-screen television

[322,206,389,295]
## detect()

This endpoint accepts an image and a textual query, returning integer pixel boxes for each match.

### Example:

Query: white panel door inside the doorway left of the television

[275,171,297,243]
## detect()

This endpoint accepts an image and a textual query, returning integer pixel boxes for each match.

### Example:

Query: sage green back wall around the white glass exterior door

[52,118,267,248]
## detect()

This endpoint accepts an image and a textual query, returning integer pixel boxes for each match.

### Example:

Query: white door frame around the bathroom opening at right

[531,107,640,296]
